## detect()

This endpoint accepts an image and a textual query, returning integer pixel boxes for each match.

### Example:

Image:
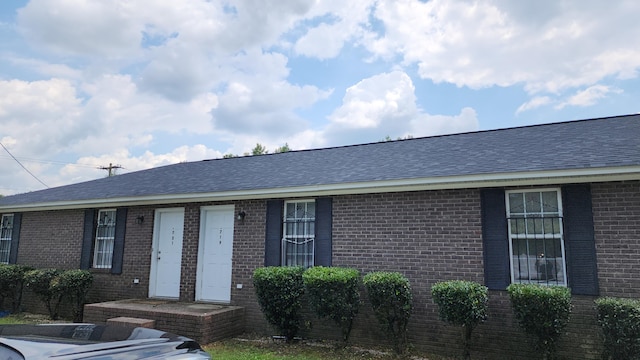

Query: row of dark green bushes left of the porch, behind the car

[0,264,93,322]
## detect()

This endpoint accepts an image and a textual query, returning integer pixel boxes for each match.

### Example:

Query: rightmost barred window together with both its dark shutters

[481,184,598,296]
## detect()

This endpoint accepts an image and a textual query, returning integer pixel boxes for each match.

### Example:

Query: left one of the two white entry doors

[149,208,184,299]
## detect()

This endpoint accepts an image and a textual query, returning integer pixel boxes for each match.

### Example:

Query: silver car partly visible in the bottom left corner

[0,324,209,360]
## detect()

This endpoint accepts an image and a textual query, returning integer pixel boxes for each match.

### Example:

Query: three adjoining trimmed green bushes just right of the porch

[253,266,412,352]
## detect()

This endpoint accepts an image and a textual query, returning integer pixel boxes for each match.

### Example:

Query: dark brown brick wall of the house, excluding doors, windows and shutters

[11,181,640,359]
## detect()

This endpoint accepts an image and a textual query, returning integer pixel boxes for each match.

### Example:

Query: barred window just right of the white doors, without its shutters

[282,200,316,268]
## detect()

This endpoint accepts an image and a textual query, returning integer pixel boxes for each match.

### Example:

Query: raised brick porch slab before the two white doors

[83,299,245,344]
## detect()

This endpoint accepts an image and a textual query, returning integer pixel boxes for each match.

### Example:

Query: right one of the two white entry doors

[196,205,234,303]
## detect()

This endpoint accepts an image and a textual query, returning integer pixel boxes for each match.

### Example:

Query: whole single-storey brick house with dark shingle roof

[0,115,640,358]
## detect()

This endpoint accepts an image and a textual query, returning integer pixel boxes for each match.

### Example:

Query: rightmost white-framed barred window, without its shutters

[506,189,567,286]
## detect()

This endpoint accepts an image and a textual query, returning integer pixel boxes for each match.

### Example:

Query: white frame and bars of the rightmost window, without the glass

[505,188,567,286]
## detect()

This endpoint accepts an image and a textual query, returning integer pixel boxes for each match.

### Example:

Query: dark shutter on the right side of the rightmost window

[562,184,599,296]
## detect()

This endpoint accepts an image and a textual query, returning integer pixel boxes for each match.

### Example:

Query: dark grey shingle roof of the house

[0,115,640,208]
